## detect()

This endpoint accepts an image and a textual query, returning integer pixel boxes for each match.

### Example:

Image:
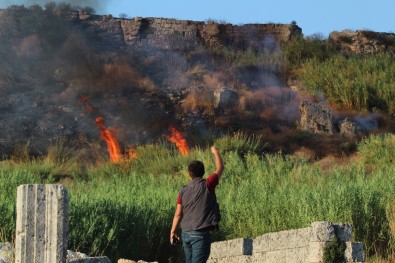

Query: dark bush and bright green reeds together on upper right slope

[285,36,395,116]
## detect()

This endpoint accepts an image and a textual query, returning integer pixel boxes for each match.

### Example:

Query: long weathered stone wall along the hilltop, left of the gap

[80,16,302,50]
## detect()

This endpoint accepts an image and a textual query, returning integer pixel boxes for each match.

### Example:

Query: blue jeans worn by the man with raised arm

[181,231,211,263]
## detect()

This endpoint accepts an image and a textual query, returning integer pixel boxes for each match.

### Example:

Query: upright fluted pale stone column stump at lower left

[15,184,69,263]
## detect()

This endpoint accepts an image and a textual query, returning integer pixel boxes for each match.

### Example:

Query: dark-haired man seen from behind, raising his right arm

[170,146,224,263]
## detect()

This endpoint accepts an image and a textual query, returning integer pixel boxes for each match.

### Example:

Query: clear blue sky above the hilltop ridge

[0,0,395,37]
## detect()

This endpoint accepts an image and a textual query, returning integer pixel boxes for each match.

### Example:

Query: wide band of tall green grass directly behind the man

[0,135,395,262]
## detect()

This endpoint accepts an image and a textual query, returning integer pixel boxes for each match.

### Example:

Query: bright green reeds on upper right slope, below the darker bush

[299,54,395,115]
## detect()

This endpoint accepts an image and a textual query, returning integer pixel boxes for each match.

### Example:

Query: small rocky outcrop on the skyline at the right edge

[329,30,395,54]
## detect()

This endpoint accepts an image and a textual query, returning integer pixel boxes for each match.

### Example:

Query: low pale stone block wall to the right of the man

[208,222,365,263]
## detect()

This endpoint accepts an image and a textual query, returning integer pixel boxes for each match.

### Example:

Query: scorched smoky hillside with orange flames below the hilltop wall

[0,2,395,162]
